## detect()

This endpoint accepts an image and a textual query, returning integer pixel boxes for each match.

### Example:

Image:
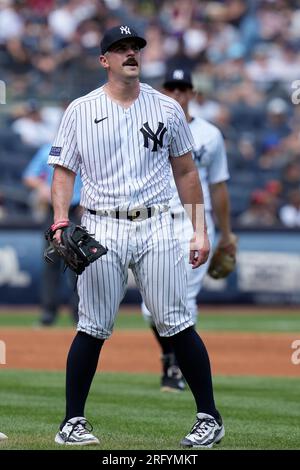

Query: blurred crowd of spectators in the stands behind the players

[0,0,300,227]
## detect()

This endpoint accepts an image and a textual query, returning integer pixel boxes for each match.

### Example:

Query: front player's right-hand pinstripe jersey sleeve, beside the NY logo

[169,100,195,157]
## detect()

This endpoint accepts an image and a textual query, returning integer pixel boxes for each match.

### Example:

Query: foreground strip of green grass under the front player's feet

[0,370,300,450]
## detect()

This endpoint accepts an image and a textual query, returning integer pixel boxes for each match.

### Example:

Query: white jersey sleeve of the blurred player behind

[207,130,229,184]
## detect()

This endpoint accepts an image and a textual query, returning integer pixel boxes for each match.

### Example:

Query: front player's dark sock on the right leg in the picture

[171,327,220,418]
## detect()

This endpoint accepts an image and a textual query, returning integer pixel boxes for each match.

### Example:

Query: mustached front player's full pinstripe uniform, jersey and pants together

[48,84,193,338]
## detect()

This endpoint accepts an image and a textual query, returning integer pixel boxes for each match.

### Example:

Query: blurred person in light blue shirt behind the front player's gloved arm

[23,144,82,326]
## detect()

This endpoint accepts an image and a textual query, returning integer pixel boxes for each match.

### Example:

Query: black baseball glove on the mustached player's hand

[44,221,107,274]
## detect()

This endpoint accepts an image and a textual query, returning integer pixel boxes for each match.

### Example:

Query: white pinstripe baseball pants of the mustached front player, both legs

[77,212,193,338]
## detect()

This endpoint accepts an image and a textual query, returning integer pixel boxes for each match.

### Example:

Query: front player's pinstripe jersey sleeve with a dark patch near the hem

[48,102,81,173]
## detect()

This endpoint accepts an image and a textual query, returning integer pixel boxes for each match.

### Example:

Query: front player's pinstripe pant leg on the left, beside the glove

[77,214,128,339]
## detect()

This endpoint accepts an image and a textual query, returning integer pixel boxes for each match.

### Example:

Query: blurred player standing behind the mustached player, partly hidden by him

[142,69,236,391]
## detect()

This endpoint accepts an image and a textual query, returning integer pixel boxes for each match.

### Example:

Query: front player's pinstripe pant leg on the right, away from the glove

[132,213,193,336]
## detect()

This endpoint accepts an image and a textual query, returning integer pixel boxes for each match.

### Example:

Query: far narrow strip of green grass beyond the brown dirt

[0,307,300,333]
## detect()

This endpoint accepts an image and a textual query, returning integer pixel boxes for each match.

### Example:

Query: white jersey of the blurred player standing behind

[170,117,229,212]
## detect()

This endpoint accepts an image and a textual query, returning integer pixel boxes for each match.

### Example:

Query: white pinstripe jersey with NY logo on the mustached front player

[48,83,194,210]
